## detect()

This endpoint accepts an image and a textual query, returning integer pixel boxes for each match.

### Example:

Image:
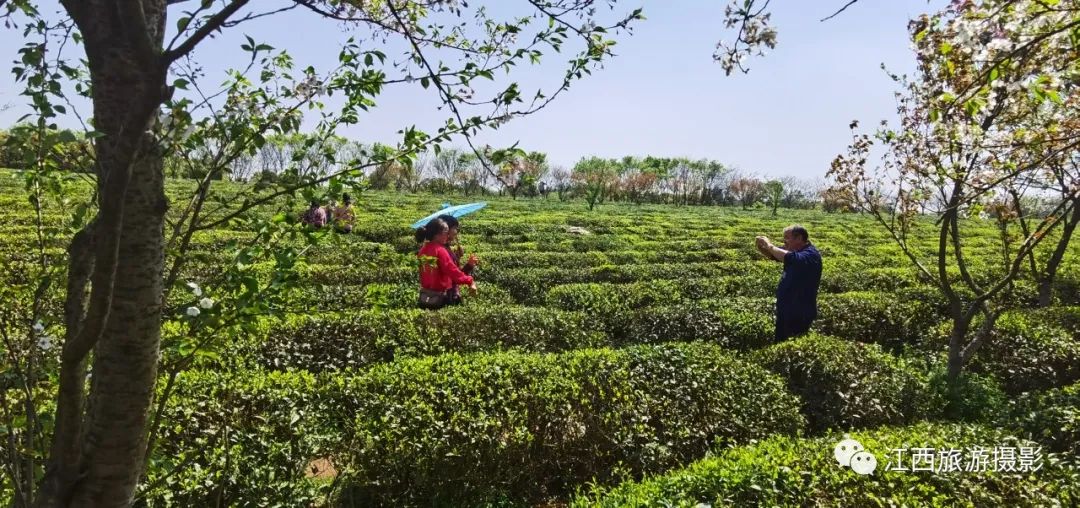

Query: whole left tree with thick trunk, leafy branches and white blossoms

[0,0,640,506]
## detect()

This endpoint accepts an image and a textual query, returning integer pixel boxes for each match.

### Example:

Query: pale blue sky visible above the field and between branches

[0,0,944,178]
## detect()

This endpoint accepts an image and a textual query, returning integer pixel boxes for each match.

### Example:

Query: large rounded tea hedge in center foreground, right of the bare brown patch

[332,344,804,506]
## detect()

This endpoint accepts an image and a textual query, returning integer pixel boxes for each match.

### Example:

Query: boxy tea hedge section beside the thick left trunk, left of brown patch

[136,371,332,506]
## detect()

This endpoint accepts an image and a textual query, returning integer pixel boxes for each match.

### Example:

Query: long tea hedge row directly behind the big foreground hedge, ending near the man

[254,304,773,372]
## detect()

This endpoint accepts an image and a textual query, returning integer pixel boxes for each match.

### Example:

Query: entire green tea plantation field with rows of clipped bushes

[0,175,1080,507]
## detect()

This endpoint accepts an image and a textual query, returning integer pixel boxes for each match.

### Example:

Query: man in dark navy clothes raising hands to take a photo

[756,225,821,343]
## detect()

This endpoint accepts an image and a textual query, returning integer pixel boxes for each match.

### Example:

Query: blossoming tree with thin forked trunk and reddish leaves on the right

[828,0,1080,380]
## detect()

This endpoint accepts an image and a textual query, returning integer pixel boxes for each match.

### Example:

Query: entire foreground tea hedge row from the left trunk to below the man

[156,344,805,506]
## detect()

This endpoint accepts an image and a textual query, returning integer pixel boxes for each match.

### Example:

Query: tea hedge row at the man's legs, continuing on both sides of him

[545,285,942,352]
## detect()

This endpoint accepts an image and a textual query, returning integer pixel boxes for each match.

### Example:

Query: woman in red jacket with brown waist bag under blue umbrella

[416,218,476,310]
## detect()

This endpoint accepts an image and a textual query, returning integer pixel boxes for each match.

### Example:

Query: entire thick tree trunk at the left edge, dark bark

[41,0,167,507]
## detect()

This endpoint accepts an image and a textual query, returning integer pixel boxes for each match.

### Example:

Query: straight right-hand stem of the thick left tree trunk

[72,149,165,506]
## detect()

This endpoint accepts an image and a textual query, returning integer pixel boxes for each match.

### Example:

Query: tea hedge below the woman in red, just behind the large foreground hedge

[258,306,607,371]
